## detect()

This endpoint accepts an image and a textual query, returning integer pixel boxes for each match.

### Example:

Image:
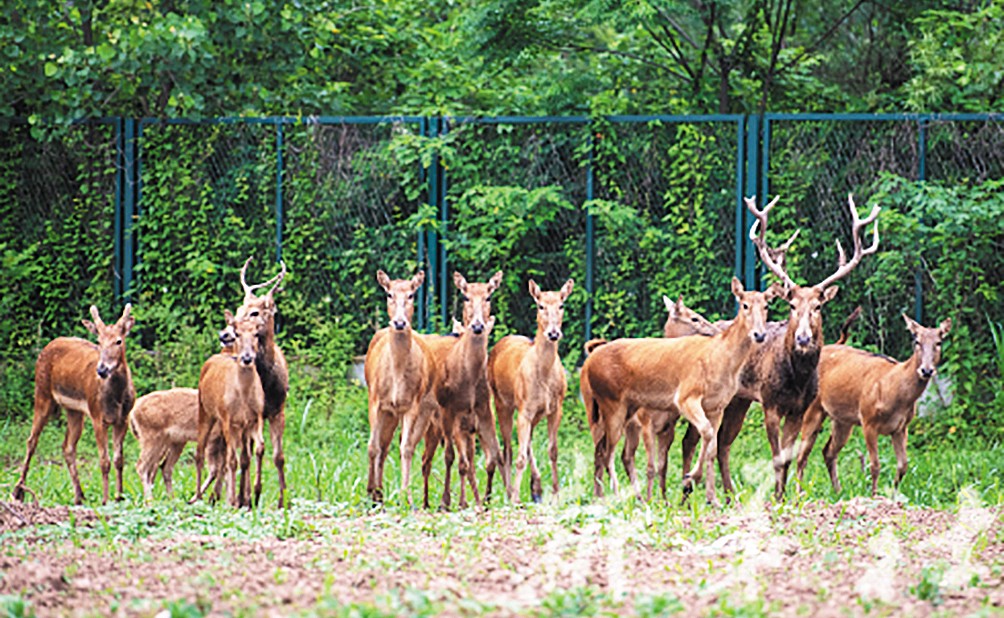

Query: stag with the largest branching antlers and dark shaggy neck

[684,194,881,501]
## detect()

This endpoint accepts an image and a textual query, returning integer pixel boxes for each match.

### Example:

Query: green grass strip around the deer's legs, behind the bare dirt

[0,384,1004,517]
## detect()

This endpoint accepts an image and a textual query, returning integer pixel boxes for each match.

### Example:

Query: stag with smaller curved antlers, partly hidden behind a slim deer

[220,257,289,509]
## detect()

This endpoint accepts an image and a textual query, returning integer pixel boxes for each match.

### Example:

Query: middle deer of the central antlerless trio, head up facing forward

[422,271,510,510]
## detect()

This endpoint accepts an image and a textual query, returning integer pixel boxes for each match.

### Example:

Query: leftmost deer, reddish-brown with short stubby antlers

[12,305,136,505]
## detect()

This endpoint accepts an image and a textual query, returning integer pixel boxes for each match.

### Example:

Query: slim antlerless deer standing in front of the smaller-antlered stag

[195,310,270,507]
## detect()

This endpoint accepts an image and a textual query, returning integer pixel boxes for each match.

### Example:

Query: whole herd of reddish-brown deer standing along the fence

[5,196,951,509]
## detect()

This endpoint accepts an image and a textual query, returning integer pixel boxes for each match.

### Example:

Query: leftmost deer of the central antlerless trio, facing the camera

[364,271,436,505]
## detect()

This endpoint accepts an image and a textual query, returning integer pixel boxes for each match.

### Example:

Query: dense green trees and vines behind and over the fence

[0,0,1004,441]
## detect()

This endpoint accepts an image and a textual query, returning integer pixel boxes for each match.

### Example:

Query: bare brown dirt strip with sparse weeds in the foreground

[0,499,1004,616]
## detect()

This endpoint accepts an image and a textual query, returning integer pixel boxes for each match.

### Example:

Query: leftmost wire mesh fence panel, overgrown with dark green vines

[0,122,118,353]
